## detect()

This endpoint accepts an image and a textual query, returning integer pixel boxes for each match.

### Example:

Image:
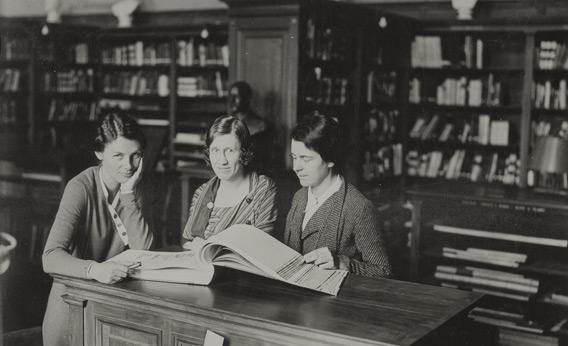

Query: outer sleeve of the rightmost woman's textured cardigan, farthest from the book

[349,202,391,277]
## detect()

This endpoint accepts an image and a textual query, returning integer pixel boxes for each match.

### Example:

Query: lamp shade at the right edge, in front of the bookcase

[529,136,568,173]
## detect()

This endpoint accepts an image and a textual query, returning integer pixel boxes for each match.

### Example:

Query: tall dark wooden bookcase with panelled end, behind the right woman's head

[226,0,377,176]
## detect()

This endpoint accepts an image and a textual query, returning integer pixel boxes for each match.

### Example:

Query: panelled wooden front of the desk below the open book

[85,294,352,346]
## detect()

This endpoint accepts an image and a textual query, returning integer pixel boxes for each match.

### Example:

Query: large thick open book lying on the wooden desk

[109,225,347,295]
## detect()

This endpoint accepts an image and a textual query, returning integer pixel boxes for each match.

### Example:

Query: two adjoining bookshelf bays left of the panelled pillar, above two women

[97,26,229,168]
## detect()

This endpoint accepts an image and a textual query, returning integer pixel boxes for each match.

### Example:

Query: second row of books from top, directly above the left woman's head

[102,71,170,96]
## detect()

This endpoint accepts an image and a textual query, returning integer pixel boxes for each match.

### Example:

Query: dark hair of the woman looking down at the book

[290,112,343,169]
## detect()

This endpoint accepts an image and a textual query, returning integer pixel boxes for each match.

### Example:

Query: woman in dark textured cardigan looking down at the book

[284,113,391,277]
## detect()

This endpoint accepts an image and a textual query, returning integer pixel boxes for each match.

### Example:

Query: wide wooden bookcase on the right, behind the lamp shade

[405,22,568,190]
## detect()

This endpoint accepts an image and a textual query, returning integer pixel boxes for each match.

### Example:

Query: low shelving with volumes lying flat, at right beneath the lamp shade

[408,181,568,345]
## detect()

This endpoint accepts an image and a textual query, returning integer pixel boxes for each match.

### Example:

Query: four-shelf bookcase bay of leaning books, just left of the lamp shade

[405,28,525,185]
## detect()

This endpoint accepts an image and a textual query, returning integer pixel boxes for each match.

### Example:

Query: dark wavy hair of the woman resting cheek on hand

[95,113,146,152]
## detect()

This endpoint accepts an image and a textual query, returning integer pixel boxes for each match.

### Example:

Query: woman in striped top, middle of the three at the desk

[183,115,277,240]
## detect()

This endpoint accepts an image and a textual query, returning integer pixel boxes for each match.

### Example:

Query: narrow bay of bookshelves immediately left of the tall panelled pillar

[171,27,229,168]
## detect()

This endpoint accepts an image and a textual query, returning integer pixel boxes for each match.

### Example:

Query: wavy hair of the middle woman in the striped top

[205,115,254,167]
